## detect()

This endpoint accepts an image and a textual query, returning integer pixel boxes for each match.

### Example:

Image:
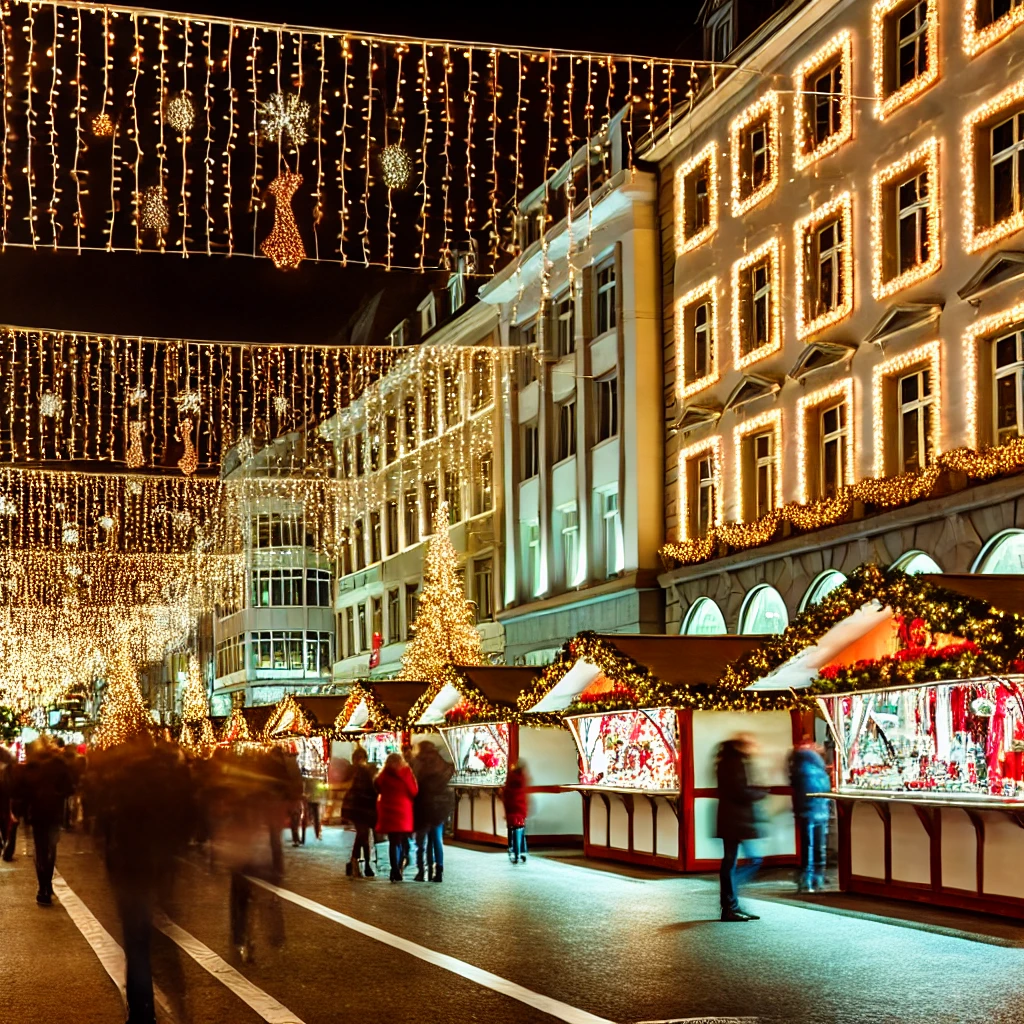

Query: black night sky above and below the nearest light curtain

[0,0,699,343]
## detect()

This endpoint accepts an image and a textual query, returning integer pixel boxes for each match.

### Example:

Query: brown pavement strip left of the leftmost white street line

[0,837,125,1024]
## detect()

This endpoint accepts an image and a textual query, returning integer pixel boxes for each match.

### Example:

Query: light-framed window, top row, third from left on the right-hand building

[793,32,853,169]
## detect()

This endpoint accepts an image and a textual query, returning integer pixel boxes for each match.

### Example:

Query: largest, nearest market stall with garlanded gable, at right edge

[724,566,1024,918]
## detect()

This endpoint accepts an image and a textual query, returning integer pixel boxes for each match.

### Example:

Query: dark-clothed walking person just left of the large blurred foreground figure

[12,735,75,906]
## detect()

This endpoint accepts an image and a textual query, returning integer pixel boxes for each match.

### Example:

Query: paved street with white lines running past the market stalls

[0,829,1024,1024]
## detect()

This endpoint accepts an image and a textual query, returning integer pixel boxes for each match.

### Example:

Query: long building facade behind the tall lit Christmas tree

[321,272,509,681]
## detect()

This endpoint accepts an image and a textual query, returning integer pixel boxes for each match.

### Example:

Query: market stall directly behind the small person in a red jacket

[410,666,583,846]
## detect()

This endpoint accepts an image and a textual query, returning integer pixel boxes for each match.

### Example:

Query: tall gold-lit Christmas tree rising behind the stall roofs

[401,502,483,682]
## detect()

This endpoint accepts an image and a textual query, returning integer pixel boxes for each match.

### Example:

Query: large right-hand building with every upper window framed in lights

[641,0,1024,633]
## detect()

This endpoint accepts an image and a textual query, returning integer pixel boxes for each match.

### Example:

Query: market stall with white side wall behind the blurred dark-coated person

[519,633,806,871]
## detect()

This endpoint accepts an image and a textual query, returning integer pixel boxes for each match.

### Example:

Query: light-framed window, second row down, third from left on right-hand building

[796,193,853,338]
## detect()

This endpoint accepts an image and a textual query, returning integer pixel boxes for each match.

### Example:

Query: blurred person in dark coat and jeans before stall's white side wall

[716,733,767,921]
